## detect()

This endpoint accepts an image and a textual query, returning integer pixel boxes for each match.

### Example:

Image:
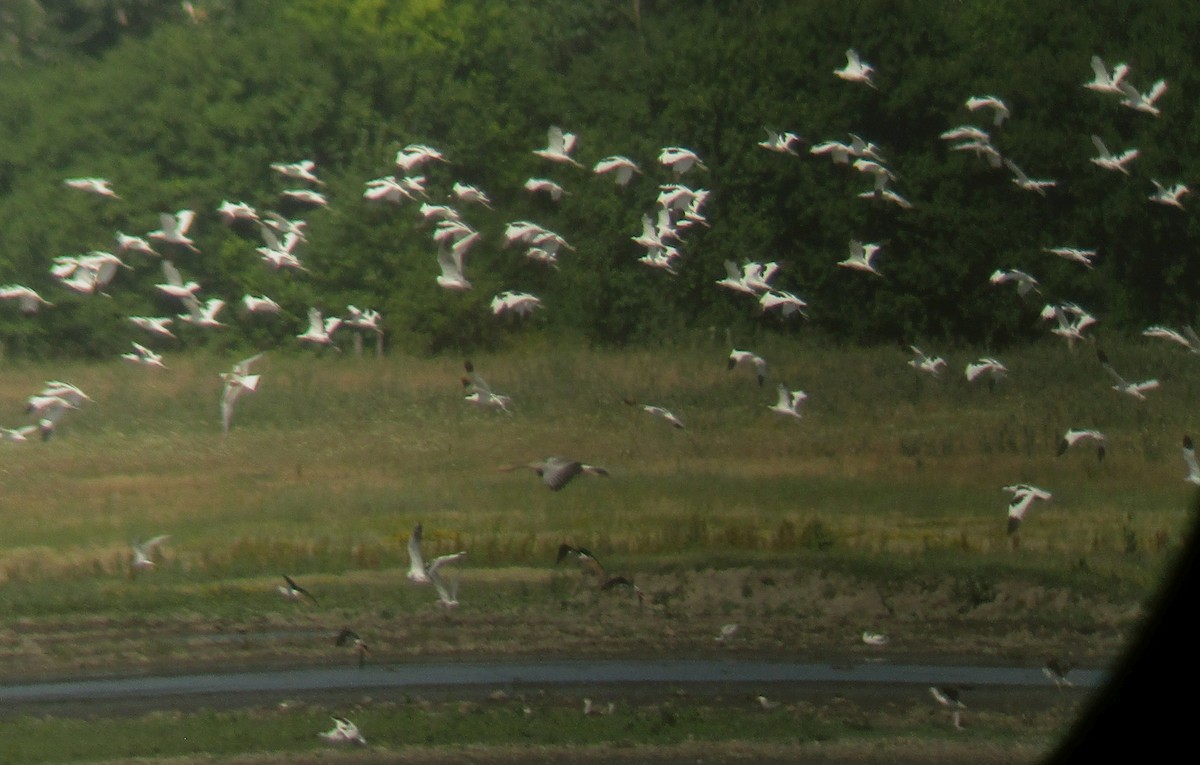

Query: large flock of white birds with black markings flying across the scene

[0,41,1200,742]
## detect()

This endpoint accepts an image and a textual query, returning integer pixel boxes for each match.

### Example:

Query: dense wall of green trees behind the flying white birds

[0,0,1200,356]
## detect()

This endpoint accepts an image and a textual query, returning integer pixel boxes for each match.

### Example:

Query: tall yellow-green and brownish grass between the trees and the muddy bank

[0,338,1200,580]
